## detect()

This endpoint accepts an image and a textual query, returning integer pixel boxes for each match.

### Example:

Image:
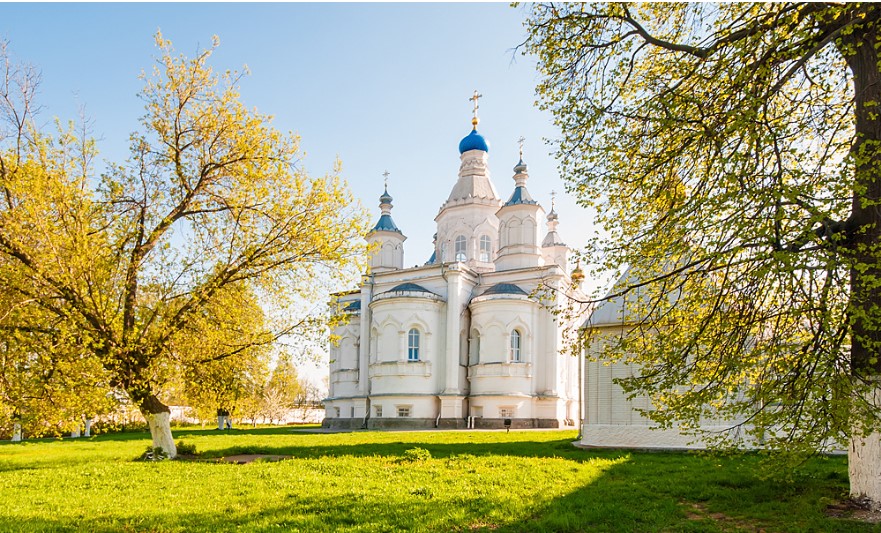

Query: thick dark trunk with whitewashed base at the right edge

[839,6,881,509]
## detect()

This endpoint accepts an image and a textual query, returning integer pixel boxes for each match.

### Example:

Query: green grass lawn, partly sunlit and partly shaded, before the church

[0,428,881,532]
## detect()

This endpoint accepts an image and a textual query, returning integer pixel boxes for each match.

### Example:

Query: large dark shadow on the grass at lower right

[492,452,881,533]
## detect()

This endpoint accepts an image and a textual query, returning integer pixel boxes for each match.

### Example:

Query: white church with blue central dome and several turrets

[324,106,579,428]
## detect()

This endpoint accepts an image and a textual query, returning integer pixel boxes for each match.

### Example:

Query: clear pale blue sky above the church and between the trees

[0,3,591,282]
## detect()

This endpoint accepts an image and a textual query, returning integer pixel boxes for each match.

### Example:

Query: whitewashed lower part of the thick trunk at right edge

[847,385,881,511]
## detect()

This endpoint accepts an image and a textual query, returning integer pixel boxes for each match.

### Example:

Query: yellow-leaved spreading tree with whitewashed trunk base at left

[0,34,366,456]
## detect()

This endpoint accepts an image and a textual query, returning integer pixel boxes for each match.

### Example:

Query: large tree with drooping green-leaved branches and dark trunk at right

[527,3,881,505]
